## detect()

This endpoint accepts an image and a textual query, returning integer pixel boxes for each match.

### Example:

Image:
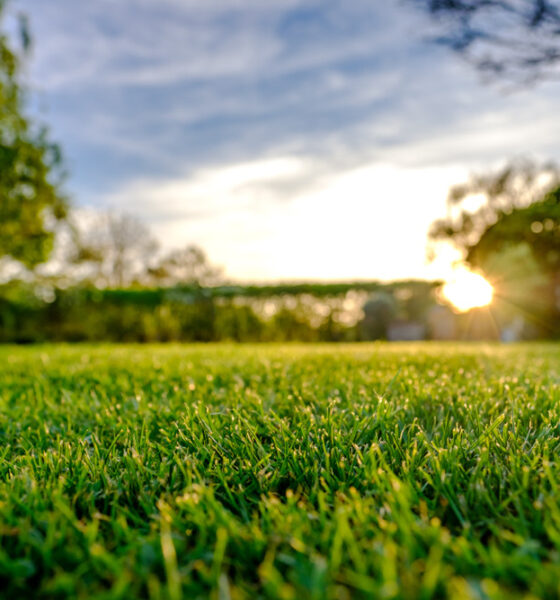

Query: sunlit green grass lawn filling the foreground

[0,344,560,600]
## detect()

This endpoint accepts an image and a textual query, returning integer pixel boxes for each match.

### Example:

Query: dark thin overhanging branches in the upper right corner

[409,0,560,81]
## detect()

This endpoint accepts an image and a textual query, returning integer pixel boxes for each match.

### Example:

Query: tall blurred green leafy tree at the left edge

[0,0,67,268]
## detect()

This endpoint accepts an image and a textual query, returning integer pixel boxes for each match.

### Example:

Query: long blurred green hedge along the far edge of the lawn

[0,281,437,343]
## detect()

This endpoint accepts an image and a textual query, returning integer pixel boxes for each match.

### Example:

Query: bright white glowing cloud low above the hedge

[98,157,465,280]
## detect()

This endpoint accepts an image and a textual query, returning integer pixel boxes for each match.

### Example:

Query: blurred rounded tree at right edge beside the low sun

[429,162,560,335]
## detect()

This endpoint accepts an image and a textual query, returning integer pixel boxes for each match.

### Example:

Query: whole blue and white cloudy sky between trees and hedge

[12,0,560,281]
